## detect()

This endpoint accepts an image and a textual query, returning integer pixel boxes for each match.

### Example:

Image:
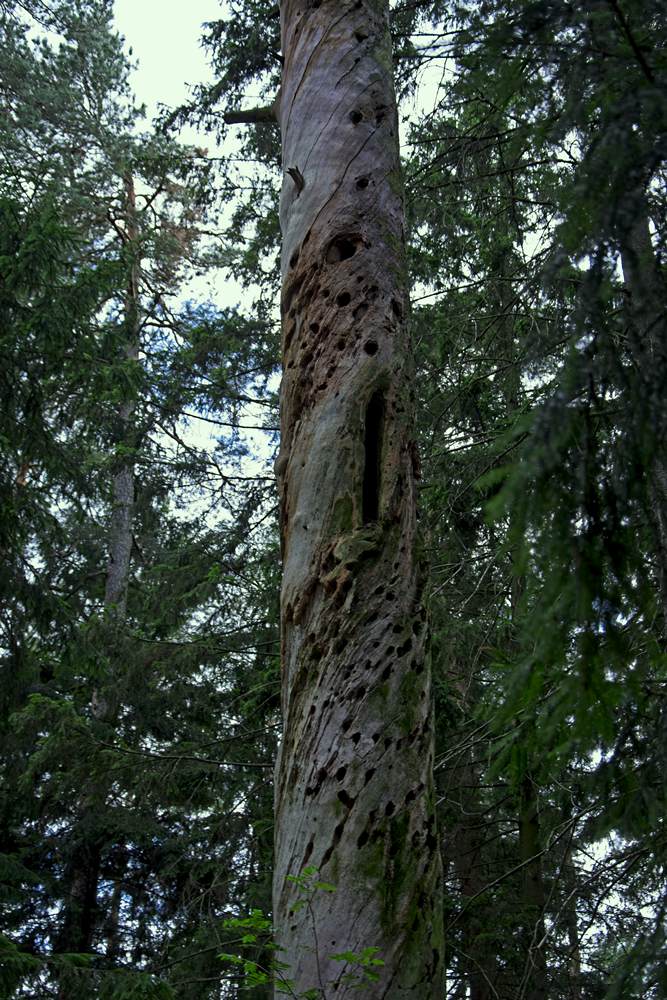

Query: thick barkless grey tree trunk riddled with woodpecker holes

[274,0,442,1000]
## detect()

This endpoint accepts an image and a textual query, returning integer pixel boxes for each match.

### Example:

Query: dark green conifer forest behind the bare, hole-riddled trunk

[0,0,667,1000]
